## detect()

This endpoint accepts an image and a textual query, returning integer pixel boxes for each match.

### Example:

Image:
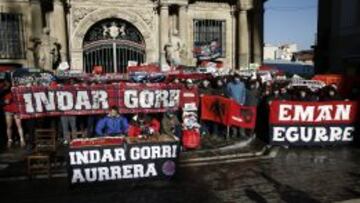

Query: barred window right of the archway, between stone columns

[193,19,226,57]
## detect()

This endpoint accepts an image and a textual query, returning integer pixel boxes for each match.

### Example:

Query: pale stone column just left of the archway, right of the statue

[51,0,68,61]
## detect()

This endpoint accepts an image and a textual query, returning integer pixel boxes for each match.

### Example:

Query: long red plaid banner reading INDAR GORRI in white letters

[12,83,188,119]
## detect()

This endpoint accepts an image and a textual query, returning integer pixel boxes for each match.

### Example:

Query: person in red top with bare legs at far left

[3,90,26,147]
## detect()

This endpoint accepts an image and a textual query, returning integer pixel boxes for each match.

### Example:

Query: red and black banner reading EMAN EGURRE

[269,101,357,145]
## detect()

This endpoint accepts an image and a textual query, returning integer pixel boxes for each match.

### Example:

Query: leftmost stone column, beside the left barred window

[30,0,43,38]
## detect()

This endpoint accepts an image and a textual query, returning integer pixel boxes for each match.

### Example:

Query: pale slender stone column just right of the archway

[159,4,169,64]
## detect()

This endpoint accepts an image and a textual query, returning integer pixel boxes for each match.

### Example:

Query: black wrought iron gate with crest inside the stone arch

[83,19,145,73]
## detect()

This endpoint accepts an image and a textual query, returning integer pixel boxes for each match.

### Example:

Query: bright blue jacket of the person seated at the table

[95,116,129,136]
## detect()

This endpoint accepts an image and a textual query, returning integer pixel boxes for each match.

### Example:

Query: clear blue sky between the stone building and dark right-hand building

[264,0,318,50]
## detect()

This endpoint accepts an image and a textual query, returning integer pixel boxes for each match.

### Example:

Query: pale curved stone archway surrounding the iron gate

[70,8,156,70]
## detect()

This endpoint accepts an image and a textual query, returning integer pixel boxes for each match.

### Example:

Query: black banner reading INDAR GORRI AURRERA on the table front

[67,137,180,185]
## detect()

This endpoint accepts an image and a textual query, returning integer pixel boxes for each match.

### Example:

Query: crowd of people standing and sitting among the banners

[0,69,358,150]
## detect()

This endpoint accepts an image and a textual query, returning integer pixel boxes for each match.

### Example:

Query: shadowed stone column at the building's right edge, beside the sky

[253,0,264,64]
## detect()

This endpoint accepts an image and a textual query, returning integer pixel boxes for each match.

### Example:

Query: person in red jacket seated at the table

[128,114,160,137]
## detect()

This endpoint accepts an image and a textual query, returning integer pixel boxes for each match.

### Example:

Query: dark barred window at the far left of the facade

[0,13,25,59]
